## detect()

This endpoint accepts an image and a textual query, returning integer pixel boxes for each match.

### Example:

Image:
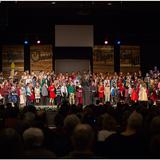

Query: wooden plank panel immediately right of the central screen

[93,45,114,73]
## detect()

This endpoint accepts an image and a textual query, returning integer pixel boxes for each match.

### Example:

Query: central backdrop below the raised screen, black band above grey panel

[55,47,92,73]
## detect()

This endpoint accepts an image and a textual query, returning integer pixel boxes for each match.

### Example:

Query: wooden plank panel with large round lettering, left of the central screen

[30,45,53,72]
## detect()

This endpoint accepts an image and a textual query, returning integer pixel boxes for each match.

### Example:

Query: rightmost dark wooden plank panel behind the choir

[120,45,140,72]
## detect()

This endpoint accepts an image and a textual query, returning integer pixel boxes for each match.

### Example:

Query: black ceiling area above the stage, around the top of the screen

[0,1,160,44]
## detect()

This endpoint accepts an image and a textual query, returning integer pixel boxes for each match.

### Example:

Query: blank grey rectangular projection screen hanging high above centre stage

[55,25,94,47]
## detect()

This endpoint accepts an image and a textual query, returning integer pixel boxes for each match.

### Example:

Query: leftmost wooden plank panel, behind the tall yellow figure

[2,45,24,74]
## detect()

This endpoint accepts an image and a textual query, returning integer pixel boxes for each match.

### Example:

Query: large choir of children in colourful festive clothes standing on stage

[0,67,160,107]
